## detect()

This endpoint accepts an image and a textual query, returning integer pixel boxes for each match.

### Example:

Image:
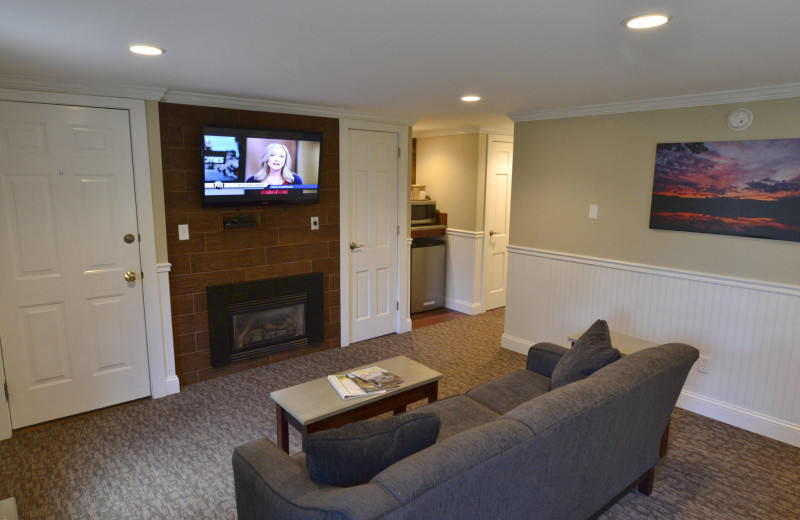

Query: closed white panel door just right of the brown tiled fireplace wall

[350,130,398,342]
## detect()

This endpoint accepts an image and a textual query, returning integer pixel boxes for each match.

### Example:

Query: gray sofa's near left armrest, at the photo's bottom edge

[233,439,397,520]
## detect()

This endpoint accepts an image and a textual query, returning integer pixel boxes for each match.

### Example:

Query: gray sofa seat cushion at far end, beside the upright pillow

[467,370,550,415]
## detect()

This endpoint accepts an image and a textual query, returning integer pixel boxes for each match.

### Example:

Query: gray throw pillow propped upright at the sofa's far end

[550,320,620,390]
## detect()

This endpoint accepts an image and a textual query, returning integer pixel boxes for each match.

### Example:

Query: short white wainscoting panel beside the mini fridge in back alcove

[444,229,483,314]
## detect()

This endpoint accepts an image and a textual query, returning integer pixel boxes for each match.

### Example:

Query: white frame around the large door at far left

[0,89,180,439]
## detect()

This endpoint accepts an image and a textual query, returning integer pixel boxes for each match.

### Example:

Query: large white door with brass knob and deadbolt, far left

[0,101,150,428]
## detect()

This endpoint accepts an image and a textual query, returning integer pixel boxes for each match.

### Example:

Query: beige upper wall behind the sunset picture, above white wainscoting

[510,98,800,285]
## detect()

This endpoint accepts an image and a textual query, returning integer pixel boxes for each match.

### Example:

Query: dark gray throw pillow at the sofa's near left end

[303,413,441,487]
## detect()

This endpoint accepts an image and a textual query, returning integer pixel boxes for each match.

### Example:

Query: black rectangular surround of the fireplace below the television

[206,272,325,367]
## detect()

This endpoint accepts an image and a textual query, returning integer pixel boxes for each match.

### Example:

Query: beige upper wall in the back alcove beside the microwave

[417,133,486,231]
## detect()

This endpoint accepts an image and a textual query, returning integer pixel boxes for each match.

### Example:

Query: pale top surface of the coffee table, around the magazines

[269,356,442,425]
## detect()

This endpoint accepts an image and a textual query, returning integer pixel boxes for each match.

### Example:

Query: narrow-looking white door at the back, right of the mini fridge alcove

[483,135,514,311]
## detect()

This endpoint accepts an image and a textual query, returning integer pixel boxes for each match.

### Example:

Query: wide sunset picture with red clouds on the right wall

[650,139,800,242]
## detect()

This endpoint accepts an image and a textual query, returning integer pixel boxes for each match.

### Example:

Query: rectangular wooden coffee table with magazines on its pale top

[269,356,442,453]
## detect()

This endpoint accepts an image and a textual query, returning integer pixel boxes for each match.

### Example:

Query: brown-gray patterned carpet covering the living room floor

[0,310,800,520]
